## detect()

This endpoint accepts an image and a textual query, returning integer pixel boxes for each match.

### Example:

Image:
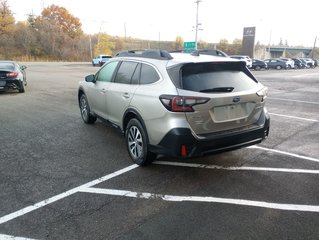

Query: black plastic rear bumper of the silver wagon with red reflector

[149,109,270,158]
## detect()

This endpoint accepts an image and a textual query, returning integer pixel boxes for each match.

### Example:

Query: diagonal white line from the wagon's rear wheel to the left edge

[0,164,138,224]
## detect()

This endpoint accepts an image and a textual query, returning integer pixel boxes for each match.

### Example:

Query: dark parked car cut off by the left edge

[0,61,27,93]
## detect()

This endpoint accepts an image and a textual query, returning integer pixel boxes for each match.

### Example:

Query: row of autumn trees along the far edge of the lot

[0,0,246,61]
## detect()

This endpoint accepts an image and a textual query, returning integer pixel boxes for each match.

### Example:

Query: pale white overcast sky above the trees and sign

[7,0,319,47]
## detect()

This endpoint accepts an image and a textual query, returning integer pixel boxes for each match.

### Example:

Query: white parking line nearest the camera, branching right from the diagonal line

[81,188,319,212]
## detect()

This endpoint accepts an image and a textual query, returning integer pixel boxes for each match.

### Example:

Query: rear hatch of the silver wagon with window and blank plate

[170,62,266,136]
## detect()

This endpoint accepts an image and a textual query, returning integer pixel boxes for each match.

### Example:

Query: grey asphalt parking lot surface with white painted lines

[0,63,319,240]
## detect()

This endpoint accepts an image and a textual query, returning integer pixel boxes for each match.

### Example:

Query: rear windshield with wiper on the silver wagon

[181,63,257,93]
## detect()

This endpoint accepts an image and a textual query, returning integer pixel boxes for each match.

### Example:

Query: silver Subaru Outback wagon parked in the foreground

[78,50,270,165]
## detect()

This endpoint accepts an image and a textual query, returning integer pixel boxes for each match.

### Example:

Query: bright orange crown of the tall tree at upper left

[42,4,83,39]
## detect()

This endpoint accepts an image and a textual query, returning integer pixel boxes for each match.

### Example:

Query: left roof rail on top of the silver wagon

[116,49,173,60]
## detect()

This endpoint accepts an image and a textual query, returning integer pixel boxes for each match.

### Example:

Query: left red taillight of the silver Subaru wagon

[160,95,209,112]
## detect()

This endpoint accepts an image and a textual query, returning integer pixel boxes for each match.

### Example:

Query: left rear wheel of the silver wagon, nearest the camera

[125,118,156,166]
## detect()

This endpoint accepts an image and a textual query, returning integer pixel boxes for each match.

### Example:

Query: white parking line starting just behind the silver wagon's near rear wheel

[153,161,319,174]
